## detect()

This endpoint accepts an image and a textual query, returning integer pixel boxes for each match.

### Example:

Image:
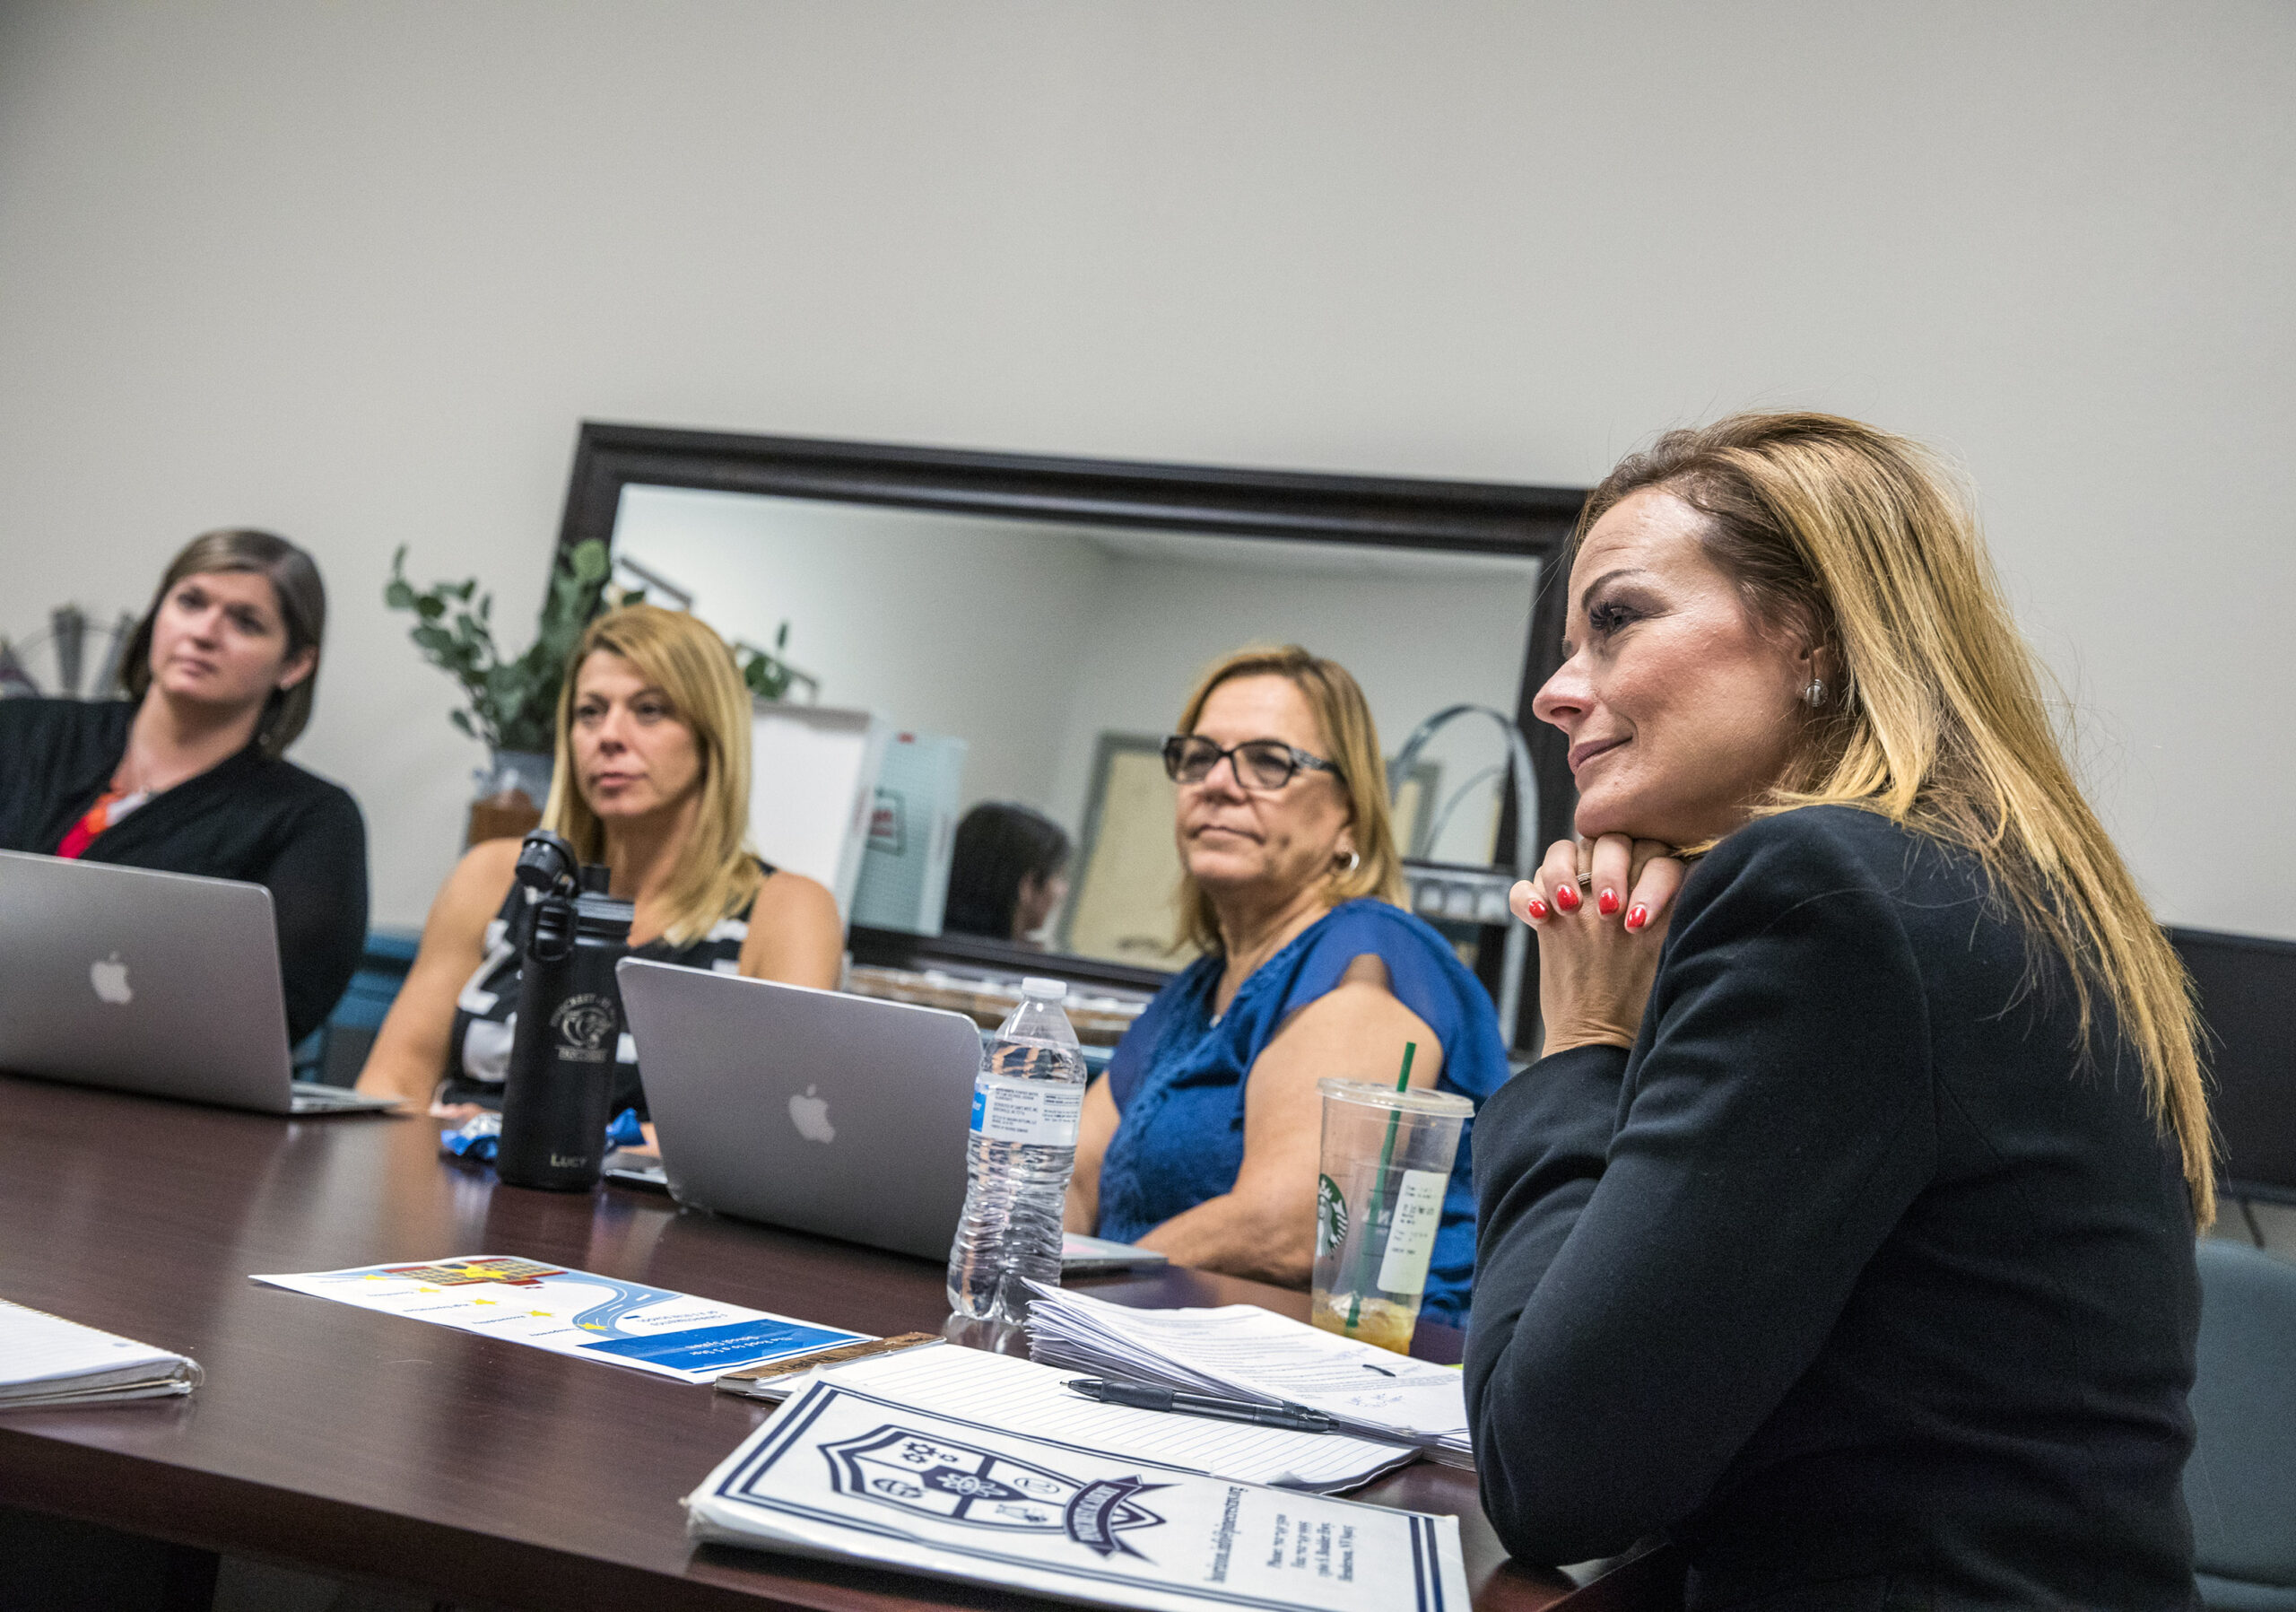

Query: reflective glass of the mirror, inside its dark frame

[613,484,1538,969]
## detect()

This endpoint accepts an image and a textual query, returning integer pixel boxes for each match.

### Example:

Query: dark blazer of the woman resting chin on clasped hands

[1467,806,2199,1612]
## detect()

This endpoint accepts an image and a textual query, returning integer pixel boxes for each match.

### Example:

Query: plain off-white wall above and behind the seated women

[0,0,2296,935]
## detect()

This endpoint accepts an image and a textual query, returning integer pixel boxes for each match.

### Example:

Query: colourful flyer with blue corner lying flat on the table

[253,1254,865,1382]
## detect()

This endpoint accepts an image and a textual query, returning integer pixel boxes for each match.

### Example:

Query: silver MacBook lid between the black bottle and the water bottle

[615,960,980,1259]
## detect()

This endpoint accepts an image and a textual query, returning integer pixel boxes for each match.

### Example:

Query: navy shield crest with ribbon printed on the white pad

[822,1426,1164,1557]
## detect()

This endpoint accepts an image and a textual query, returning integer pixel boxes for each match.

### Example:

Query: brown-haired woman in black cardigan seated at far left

[0,530,368,1041]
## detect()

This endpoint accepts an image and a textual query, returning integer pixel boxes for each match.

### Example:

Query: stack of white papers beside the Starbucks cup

[1029,1284,1474,1468]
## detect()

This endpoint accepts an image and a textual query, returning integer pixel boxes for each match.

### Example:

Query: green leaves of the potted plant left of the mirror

[384,537,620,755]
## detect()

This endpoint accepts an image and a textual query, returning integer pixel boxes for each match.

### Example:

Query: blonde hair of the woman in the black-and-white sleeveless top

[542,604,764,946]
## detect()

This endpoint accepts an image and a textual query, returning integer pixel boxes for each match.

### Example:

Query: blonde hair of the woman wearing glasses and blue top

[1176,643,1403,951]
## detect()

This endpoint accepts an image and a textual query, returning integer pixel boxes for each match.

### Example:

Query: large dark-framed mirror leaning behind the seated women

[561,423,1584,1056]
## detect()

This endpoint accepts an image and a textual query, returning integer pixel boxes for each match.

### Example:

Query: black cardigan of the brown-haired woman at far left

[0,701,368,1041]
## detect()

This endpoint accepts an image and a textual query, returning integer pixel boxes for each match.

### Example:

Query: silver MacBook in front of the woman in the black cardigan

[0,852,395,1114]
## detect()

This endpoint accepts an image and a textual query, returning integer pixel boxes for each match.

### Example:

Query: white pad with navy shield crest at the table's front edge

[684,1378,1467,1612]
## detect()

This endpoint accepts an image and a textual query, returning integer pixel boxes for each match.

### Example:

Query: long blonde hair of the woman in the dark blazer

[1578,414,2215,1226]
